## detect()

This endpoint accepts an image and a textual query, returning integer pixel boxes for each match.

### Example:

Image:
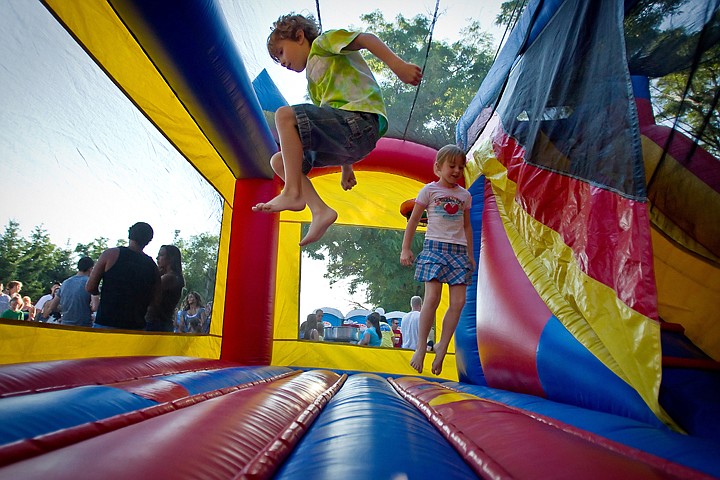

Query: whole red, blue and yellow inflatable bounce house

[0,0,720,479]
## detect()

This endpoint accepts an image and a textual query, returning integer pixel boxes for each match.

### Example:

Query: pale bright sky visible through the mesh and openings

[0,0,503,318]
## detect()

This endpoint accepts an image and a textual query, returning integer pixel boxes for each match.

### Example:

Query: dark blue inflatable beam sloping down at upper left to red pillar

[110,0,277,179]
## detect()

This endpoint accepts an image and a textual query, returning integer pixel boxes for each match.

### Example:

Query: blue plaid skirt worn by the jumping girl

[415,239,473,285]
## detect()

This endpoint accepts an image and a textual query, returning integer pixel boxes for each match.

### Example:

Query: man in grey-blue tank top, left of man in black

[42,257,95,327]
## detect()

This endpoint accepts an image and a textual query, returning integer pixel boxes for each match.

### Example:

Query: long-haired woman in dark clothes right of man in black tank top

[145,245,185,332]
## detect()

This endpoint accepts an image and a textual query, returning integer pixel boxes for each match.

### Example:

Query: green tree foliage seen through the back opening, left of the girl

[303,224,424,312]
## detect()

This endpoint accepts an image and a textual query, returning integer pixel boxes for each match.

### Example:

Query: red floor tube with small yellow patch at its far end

[393,377,702,478]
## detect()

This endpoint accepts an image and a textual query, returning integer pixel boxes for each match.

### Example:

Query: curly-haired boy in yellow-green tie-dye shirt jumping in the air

[253,14,422,246]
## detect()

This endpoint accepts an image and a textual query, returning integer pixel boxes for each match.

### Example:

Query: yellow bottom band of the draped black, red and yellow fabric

[481,136,673,425]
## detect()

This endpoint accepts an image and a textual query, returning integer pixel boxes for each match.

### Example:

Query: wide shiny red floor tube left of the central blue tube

[0,372,343,478]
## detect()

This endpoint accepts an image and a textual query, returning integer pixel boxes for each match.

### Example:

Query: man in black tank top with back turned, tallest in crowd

[86,222,160,330]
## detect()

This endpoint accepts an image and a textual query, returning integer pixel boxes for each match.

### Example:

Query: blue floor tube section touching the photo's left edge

[0,386,157,445]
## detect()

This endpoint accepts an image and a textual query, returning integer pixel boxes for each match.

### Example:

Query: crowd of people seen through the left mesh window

[0,222,212,334]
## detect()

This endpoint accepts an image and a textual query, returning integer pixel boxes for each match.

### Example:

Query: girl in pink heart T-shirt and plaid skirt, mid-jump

[400,145,475,375]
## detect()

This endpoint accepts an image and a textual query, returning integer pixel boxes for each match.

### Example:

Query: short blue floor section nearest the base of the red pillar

[163,367,293,395]
